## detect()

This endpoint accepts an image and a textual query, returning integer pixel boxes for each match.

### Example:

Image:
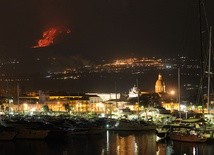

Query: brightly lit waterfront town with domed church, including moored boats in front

[0,74,214,142]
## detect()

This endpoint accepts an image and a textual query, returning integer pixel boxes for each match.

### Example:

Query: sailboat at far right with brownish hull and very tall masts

[170,0,214,142]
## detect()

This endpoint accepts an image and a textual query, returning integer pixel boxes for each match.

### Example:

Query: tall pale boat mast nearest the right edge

[207,26,212,113]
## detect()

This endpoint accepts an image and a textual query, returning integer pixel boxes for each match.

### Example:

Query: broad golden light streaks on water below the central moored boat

[107,131,156,155]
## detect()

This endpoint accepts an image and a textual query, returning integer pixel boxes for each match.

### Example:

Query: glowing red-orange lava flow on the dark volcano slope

[33,28,71,48]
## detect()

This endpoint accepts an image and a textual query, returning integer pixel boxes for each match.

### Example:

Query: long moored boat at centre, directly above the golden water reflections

[107,119,156,131]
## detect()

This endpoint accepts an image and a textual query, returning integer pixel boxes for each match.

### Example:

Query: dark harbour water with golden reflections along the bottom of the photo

[0,131,214,155]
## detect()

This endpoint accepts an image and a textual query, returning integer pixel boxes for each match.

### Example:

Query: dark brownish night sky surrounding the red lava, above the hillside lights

[0,0,214,60]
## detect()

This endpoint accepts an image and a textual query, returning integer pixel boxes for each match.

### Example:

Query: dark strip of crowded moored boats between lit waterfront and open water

[0,109,214,142]
